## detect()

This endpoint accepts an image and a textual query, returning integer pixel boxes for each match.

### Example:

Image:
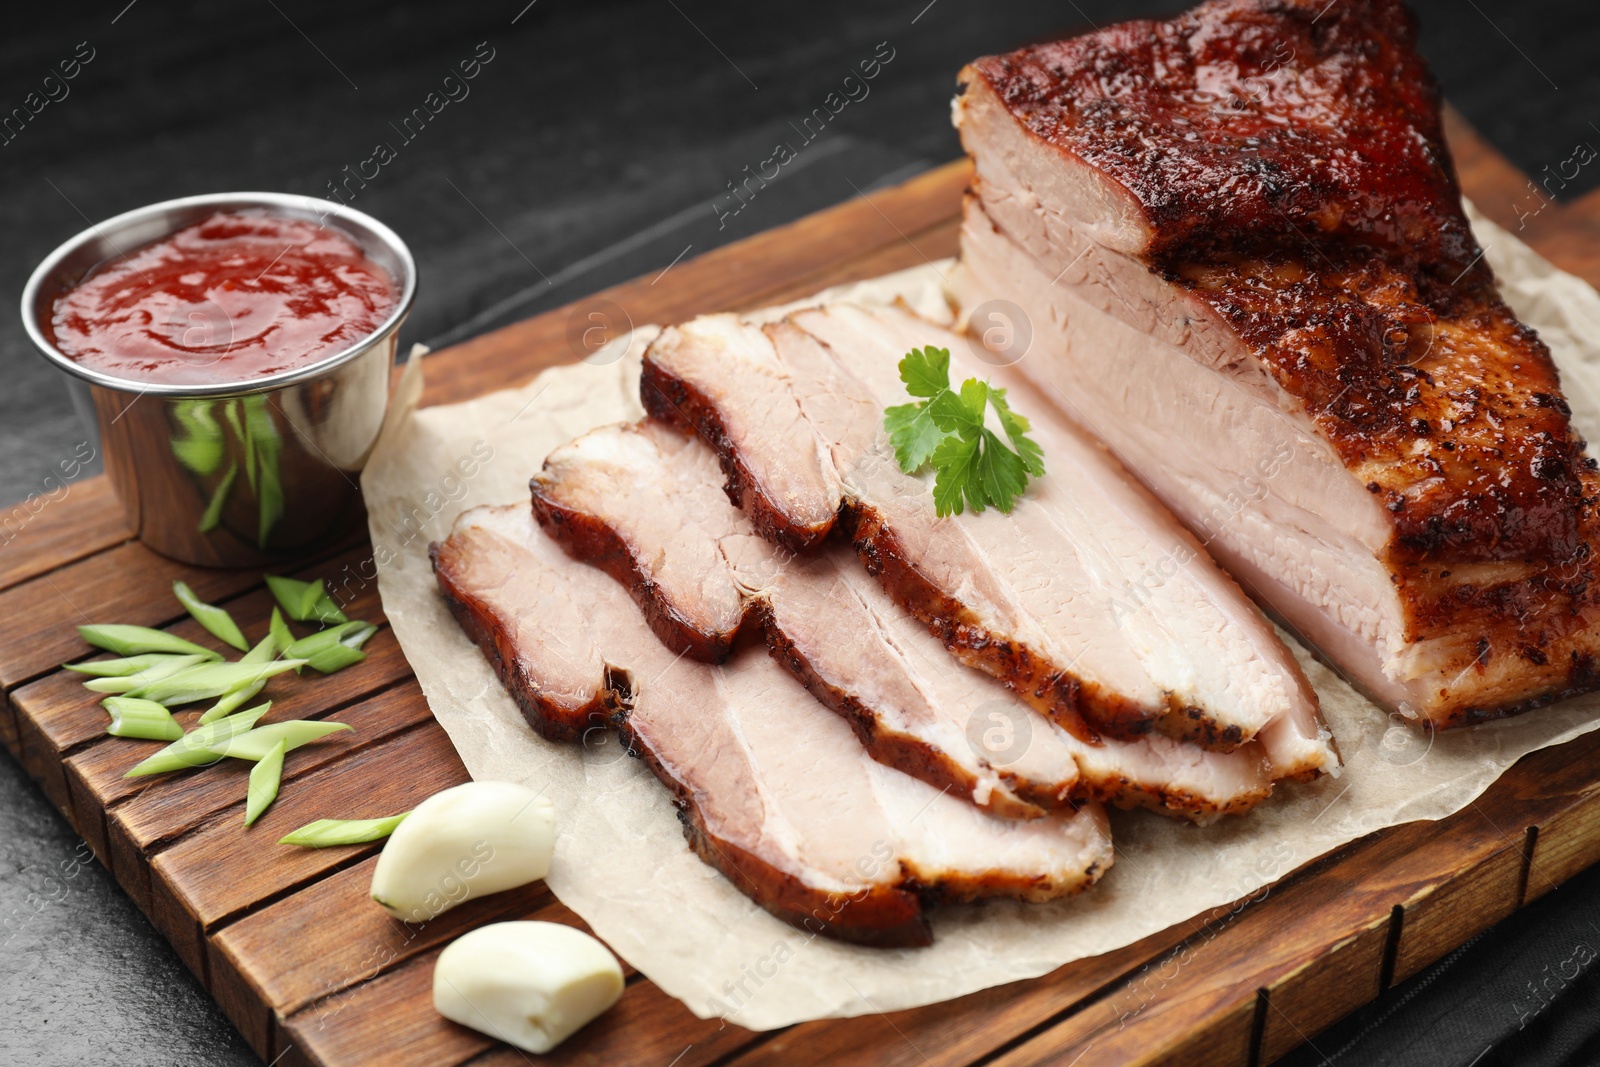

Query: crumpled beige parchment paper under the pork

[362,199,1600,1029]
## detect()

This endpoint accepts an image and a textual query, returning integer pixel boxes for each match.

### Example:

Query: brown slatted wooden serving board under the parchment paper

[9,117,1600,1067]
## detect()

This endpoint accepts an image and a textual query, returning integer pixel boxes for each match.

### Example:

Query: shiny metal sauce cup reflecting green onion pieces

[22,192,416,566]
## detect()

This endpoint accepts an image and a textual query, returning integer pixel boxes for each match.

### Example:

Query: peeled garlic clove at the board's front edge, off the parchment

[435,921,622,1053]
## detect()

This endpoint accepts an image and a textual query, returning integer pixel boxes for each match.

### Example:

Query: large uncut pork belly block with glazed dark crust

[955,0,1600,726]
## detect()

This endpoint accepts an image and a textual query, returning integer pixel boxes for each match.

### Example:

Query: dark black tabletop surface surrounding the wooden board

[0,0,1600,1065]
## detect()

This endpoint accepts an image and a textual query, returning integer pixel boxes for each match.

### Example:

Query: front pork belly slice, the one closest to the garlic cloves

[430,506,1112,945]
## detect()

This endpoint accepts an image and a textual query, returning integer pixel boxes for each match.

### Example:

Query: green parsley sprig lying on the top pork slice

[883,346,1045,517]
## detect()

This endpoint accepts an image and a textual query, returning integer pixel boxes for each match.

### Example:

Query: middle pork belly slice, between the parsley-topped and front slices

[533,419,1272,819]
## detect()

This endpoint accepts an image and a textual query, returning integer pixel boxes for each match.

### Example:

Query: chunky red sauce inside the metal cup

[51,211,400,386]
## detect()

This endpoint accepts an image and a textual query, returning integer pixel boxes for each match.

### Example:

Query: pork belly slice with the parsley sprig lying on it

[642,304,1336,777]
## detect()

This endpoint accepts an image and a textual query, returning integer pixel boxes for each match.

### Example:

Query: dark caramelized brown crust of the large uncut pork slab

[963,0,1600,726]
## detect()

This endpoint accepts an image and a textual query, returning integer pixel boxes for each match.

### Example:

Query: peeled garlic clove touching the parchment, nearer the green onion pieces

[373,782,555,923]
